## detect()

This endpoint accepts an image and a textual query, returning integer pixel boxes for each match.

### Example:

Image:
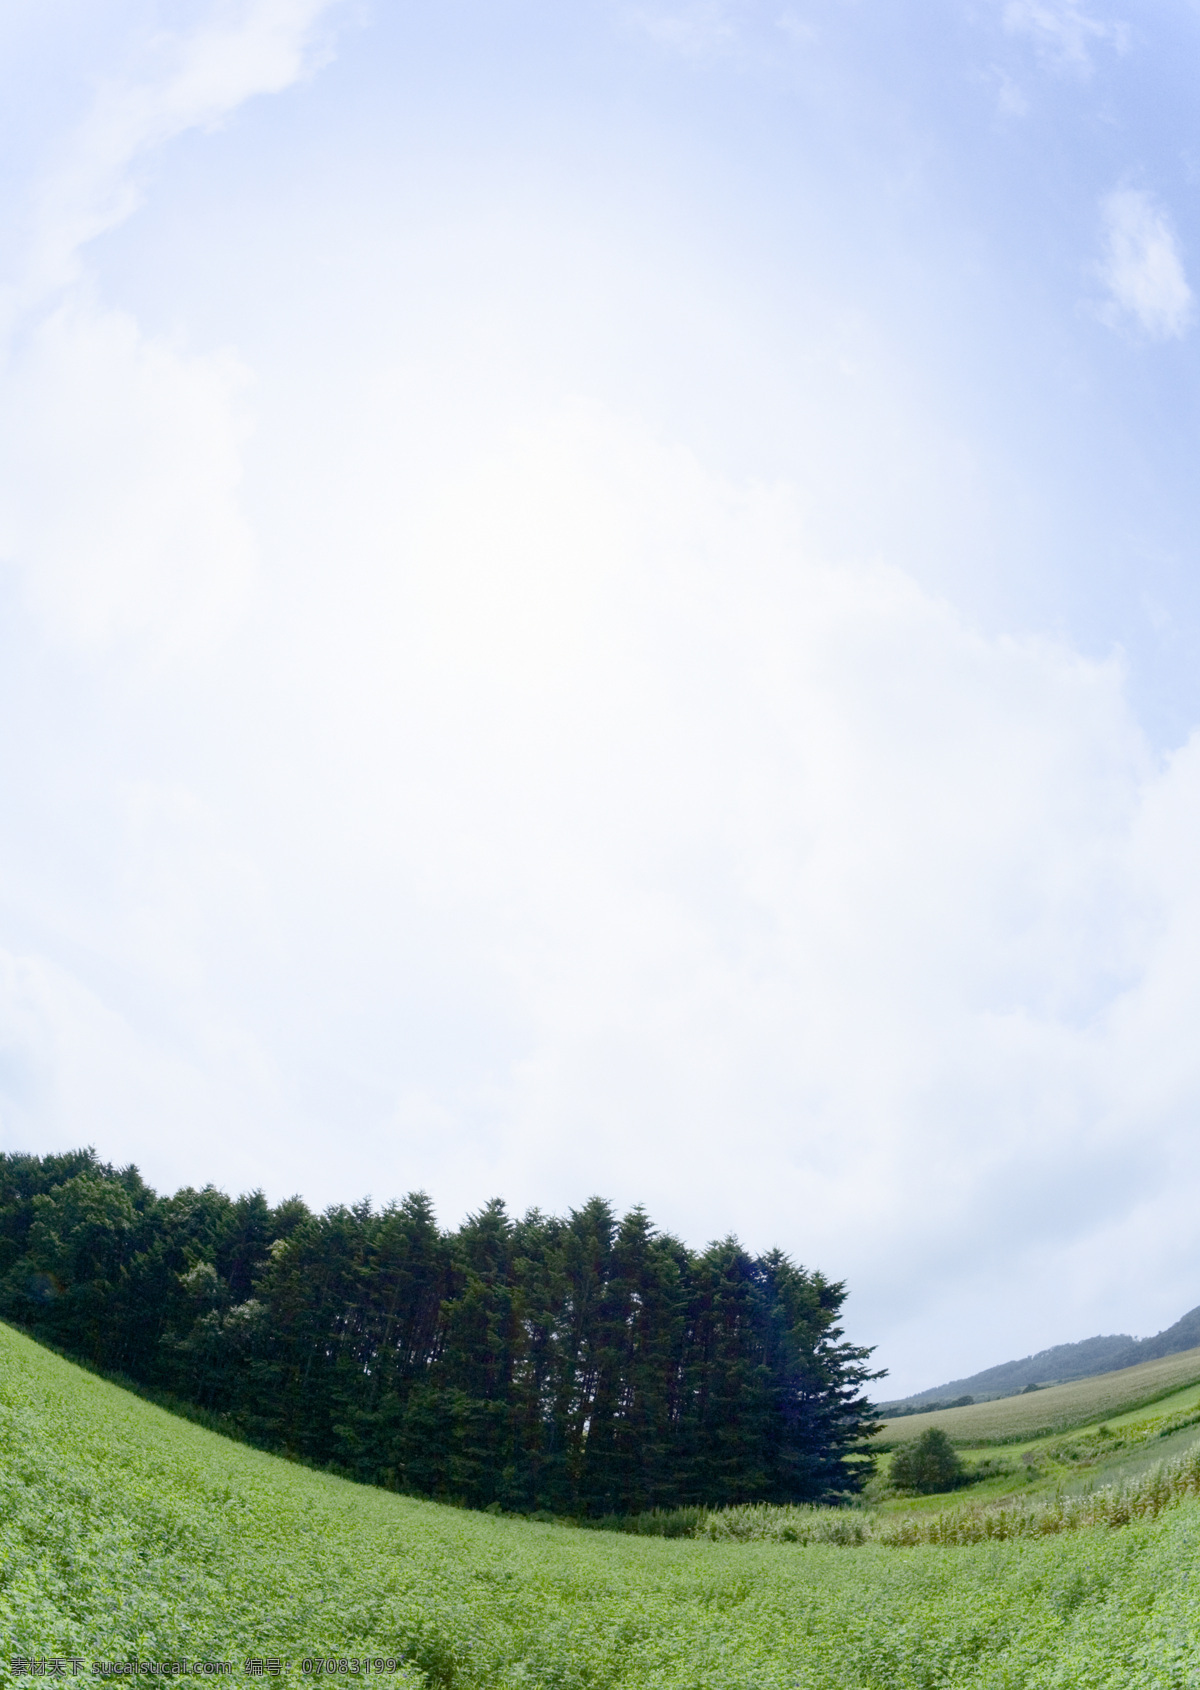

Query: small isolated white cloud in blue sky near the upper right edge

[1100,188,1195,340]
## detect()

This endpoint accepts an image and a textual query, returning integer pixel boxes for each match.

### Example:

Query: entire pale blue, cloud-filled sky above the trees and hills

[0,0,1200,1396]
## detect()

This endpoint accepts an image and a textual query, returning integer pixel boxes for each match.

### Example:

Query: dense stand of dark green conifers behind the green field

[0,1149,882,1516]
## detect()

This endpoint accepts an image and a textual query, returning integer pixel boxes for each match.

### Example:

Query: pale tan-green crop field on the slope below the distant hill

[875,1349,1200,1445]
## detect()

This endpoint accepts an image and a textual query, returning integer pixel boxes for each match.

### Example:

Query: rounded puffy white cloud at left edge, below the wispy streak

[0,296,255,648]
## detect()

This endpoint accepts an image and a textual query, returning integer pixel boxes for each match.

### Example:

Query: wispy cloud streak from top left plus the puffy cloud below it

[0,0,348,662]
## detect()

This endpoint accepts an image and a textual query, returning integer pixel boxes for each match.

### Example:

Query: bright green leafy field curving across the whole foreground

[0,1327,1200,1690]
